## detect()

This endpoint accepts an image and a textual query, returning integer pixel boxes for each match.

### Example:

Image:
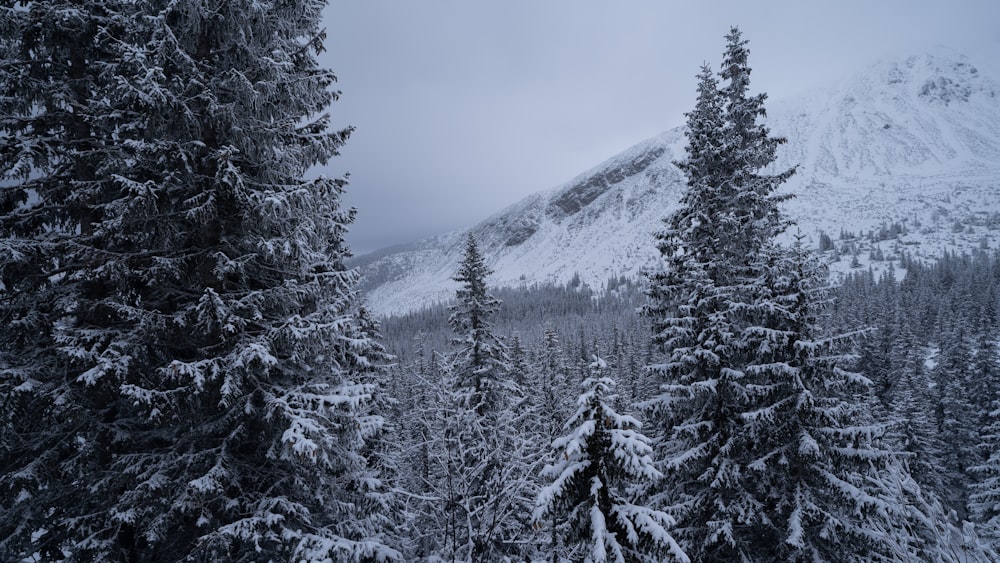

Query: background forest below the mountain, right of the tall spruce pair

[833,251,1000,535]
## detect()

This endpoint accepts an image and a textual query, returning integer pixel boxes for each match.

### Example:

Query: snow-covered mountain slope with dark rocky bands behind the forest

[356,51,1000,314]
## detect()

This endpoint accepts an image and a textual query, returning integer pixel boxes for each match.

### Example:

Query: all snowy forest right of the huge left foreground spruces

[368,30,1000,561]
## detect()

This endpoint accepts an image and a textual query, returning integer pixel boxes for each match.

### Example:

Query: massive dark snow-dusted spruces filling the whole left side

[0,0,398,561]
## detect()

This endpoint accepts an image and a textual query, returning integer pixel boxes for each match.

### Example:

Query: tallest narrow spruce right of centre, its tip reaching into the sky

[644,29,792,560]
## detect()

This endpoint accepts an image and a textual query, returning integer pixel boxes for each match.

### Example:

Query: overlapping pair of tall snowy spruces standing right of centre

[643,29,976,562]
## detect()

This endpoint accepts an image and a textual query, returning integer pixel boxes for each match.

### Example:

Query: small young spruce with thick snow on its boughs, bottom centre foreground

[533,356,688,563]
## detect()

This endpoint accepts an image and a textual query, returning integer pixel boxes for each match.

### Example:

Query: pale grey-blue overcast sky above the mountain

[322,0,1000,254]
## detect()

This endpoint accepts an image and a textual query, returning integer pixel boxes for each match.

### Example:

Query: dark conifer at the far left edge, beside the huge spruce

[0,1,137,559]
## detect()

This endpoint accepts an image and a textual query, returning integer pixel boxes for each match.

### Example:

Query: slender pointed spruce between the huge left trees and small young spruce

[429,235,539,561]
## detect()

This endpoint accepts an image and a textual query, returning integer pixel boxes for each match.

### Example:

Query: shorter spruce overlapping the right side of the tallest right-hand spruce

[742,239,946,561]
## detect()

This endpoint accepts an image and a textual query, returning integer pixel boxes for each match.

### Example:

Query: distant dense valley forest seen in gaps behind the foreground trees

[381,248,1000,560]
